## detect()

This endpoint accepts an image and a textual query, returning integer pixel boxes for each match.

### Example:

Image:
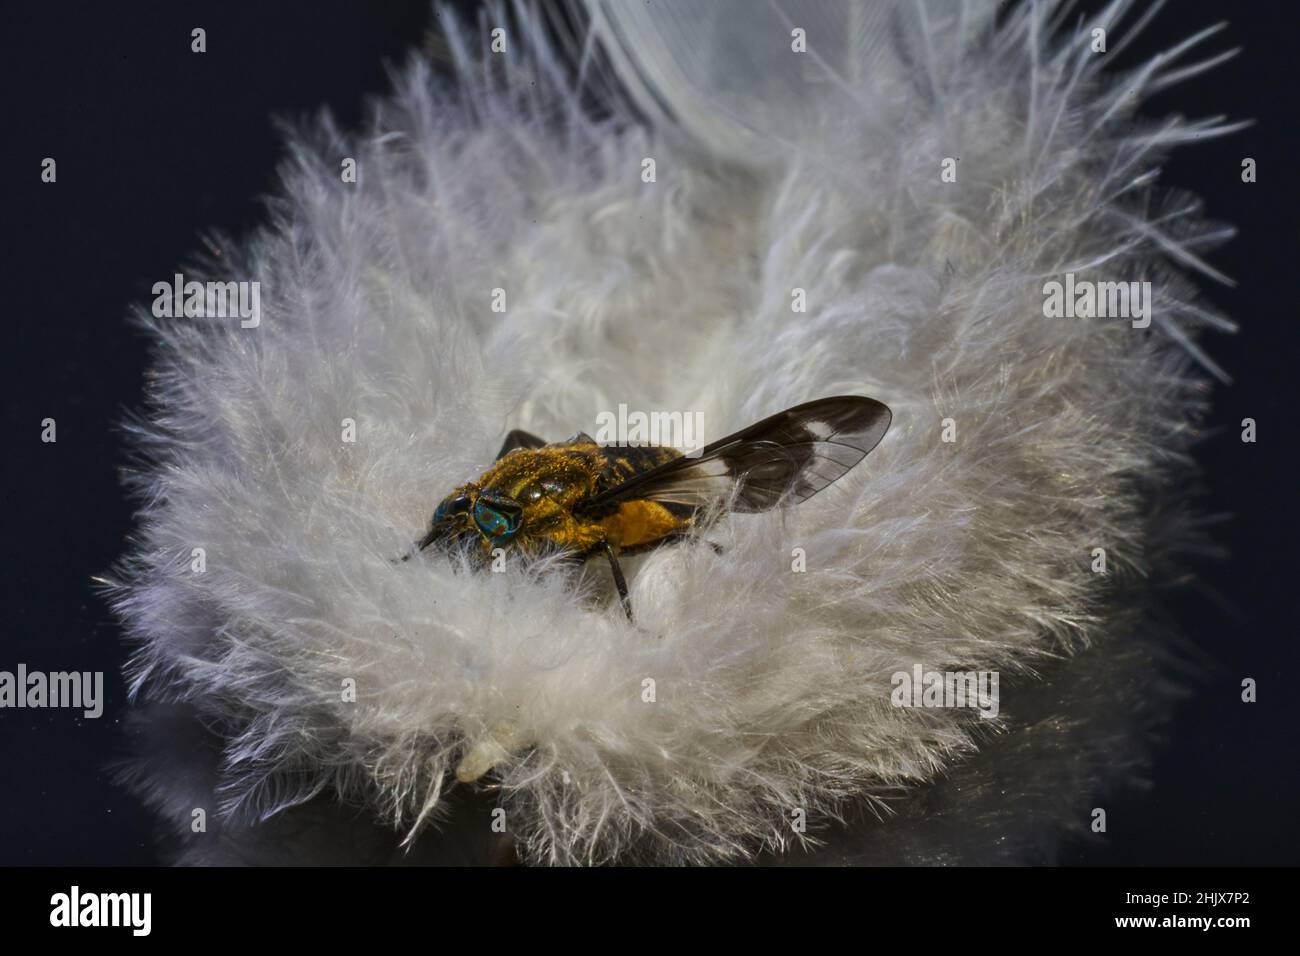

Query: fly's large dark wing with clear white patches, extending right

[588,395,892,511]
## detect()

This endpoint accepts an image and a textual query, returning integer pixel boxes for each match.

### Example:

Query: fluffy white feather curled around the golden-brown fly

[106,0,1230,862]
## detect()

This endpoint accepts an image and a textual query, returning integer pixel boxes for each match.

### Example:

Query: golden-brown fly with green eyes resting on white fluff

[403,395,892,620]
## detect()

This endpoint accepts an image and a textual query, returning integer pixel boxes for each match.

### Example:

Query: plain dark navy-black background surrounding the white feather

[0,0,1300,865]
